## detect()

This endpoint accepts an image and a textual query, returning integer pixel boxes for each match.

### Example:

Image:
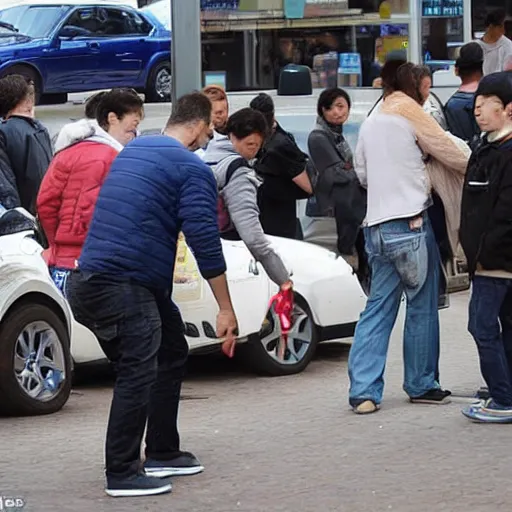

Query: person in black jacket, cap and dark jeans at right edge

[460,72,512,423]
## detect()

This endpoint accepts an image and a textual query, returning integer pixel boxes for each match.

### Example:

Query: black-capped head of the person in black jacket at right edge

[475,71,512,132]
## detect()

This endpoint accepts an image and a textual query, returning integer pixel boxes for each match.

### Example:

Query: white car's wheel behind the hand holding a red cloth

[240,295,318,376]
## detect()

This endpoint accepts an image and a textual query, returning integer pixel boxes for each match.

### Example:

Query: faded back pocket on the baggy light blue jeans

[383,231,428,289]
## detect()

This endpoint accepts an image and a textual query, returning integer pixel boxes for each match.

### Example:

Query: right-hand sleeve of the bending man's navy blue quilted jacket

[178,165,226,279]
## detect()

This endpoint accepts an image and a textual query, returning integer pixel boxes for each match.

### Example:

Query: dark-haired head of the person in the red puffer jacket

[95,88,144,146]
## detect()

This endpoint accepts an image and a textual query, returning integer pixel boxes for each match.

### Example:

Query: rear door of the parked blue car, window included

[90,7,153,87]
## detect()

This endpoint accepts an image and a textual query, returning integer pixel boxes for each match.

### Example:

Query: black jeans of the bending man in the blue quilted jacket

[67,271,188,477]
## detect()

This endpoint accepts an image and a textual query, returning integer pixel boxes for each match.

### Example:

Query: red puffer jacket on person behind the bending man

[37,133,118,269]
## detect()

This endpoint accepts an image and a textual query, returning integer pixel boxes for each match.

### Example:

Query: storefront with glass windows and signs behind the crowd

[196,0,480,90]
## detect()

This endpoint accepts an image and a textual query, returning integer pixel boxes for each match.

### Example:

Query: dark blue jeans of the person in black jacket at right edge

[468,275,512,407]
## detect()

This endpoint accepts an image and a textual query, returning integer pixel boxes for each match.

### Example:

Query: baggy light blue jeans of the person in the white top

[348,215,441,406]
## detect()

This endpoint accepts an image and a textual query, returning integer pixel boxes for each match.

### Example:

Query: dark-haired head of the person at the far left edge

[0,75,36,119]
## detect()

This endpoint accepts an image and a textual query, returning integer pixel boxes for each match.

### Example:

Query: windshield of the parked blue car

[0,5,66,39]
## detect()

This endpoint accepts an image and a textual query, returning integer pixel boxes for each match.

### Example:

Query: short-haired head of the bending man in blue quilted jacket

[165,91,213,151]
